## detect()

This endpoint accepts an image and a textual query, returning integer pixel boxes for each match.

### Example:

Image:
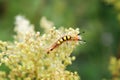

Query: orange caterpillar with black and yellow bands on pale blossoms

[47,34,85,54]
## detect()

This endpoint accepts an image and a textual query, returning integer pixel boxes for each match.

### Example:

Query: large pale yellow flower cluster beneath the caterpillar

[0,16,80,80]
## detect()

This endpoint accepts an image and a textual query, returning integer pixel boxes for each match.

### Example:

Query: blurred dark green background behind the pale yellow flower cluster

[0,0,120,80]
